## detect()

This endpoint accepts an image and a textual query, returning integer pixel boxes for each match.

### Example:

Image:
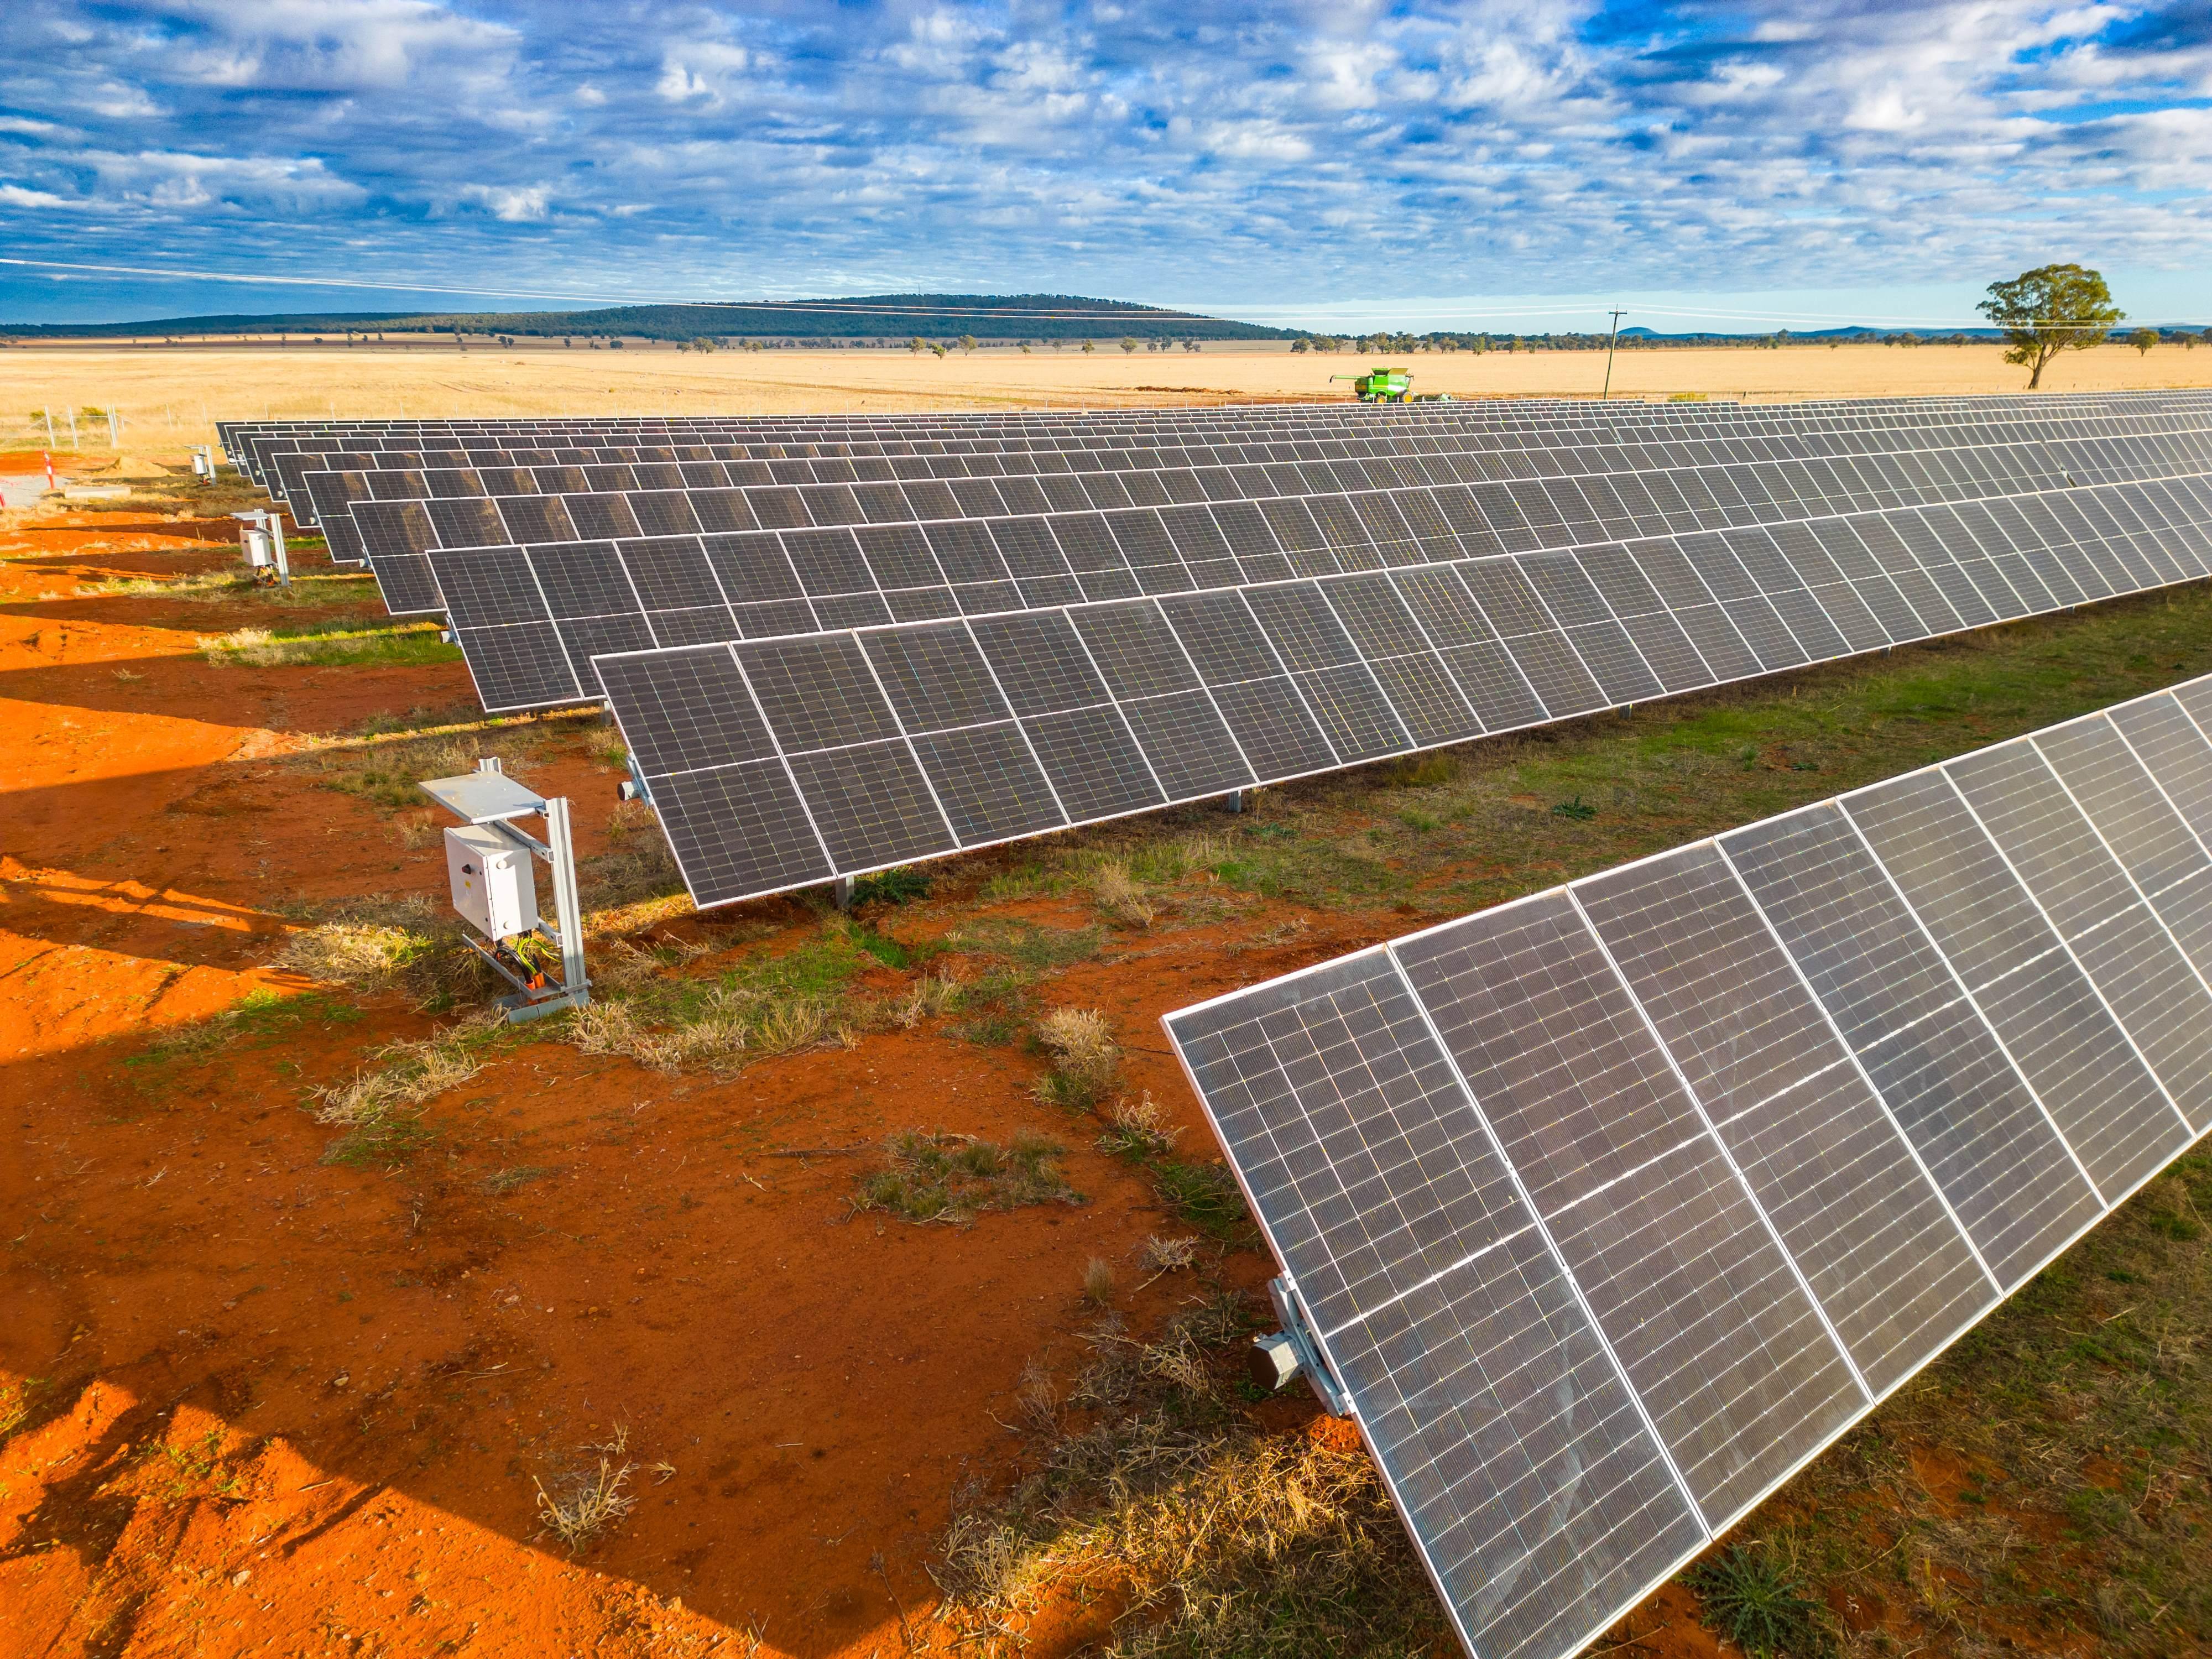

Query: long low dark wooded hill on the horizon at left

[0,294,1298,341]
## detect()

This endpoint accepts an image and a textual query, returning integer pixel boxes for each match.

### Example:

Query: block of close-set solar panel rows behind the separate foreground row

[228,394,2212,905]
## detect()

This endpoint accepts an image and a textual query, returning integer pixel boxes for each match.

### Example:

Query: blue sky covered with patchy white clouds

[0,0,2212,330]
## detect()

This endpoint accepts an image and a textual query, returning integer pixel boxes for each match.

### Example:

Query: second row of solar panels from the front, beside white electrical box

[584,473,2212,905]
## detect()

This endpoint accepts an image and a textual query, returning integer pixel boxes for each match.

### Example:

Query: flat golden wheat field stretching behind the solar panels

[0,343,2212,451]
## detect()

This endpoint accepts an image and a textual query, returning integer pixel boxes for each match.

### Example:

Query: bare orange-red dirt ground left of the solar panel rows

[0,493,1752,1659]
